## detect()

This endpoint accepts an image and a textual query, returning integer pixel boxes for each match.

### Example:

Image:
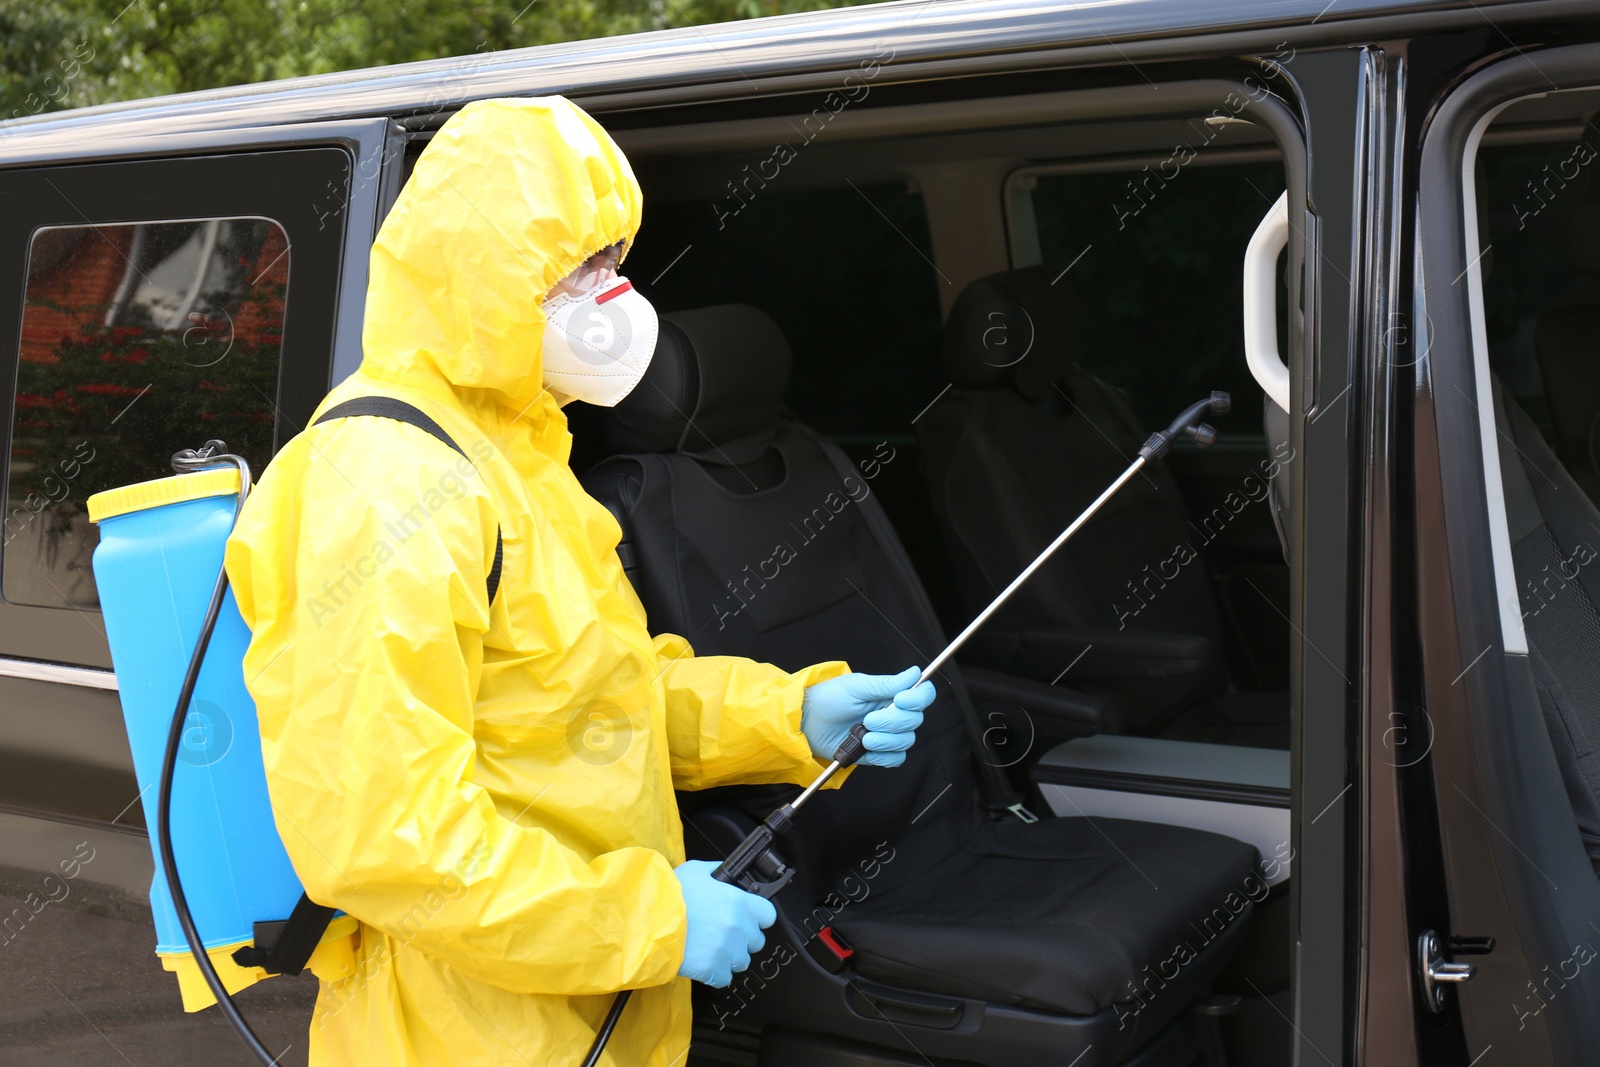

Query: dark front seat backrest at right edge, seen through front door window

[1494,382,1600,875]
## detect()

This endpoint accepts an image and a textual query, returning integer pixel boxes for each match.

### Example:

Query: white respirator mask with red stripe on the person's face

[544,243,661,408]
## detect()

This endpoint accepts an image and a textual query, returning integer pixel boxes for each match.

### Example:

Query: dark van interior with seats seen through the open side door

[556,77,1293,1067]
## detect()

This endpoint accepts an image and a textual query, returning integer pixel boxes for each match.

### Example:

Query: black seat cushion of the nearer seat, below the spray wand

[834,817,1267,1016]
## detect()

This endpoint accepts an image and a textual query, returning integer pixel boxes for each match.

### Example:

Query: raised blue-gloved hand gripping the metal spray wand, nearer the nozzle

[800,667,933,766]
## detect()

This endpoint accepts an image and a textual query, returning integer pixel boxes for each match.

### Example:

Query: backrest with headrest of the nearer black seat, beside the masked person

[582,306,984,899]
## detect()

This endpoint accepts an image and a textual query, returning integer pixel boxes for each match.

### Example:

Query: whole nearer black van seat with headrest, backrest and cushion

[584,306,1258,1067]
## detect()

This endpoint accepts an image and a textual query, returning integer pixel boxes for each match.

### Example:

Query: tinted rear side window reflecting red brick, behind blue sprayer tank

[0,218,290,608]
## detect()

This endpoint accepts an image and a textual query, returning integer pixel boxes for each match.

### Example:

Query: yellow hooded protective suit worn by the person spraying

[227,98,848,1067]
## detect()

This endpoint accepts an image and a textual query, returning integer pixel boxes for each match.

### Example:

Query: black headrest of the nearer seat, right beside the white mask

[606,304,790,466]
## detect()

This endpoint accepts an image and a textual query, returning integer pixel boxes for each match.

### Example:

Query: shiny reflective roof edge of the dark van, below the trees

[0,0,1574,165]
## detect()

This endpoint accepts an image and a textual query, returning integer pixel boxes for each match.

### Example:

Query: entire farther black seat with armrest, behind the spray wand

[917,267,1288,747]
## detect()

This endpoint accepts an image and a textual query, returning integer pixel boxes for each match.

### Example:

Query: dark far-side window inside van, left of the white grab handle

[1034,163,1283,434]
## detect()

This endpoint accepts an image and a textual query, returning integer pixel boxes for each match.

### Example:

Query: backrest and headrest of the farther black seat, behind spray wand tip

[917,267,1222,651]
